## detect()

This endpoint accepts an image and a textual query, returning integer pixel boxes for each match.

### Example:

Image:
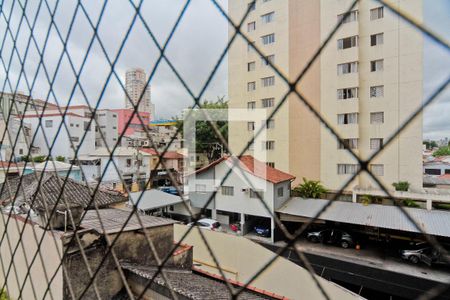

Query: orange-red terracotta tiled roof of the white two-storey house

[195,155,295,183]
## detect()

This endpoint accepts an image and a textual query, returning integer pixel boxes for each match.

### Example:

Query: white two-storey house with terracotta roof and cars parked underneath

[185,155,295,241]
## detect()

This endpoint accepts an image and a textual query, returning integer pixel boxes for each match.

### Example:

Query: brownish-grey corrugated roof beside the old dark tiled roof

[81,208,177,234]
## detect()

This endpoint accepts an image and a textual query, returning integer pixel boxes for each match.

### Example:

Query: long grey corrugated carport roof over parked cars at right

[277,198,450,237]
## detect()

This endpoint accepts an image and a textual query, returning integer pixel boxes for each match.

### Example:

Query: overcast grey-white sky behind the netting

[0,0,450,138]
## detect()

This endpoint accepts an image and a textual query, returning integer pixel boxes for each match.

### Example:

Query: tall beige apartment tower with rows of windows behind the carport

[228,0,423,190]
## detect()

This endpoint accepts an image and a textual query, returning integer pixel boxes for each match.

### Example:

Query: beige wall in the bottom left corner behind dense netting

[0,214,63,299]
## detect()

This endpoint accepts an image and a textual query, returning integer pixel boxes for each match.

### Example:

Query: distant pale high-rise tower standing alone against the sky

[125,68,155,118]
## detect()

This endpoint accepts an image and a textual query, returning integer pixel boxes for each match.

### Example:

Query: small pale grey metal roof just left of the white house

[130,190,183,210]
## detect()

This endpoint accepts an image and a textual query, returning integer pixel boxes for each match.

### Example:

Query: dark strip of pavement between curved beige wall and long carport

[262,244,450,300]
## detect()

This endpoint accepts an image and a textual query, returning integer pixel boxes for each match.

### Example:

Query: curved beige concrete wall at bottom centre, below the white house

[174,224,360,299]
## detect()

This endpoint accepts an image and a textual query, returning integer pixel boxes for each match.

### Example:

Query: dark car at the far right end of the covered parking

[400,244,450,266]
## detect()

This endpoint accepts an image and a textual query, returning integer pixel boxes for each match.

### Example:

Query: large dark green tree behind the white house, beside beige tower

[177,97,228,160]
